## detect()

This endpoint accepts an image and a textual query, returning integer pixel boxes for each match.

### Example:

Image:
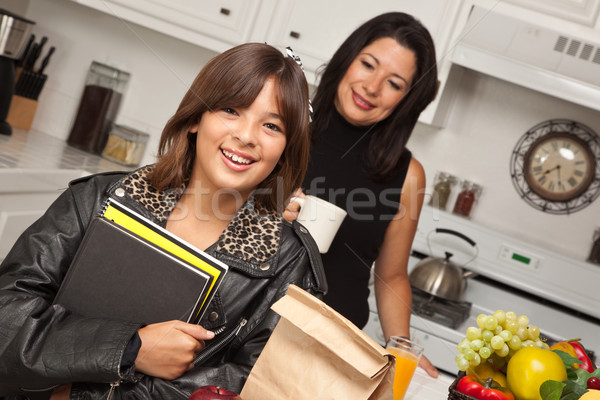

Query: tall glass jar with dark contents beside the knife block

[67,61,130,154]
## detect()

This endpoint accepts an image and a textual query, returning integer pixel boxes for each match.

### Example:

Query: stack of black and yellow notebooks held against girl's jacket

[54,204,227,324]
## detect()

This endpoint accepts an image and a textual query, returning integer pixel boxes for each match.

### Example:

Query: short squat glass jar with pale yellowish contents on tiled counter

[102,125,149,166]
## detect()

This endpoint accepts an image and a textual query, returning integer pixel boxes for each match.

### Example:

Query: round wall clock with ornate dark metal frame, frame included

[510,119,600,214]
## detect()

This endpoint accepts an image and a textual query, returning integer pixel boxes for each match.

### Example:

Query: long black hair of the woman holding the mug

[312,12,438,181]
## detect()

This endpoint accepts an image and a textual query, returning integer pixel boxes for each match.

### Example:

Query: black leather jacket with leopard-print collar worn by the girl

[0,168,326,399]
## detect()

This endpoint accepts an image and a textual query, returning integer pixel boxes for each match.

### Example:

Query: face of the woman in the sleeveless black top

[335,37,417,126]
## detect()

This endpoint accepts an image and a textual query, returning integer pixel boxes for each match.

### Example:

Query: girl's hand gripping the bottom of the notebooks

[135,321,215,380]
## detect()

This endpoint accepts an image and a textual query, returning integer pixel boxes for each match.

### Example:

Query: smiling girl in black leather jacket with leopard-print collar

[0,44,326,399]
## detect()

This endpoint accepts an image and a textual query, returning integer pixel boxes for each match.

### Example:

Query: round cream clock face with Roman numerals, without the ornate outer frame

[524,133,595,201]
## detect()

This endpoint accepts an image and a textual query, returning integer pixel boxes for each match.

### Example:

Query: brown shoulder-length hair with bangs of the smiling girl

[150,43,310,211]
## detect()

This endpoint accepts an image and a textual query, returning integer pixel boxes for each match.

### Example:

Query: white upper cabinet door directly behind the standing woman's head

[257,0,454,83]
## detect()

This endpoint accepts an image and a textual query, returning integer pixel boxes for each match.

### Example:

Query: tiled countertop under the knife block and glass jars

[0,128,132,173]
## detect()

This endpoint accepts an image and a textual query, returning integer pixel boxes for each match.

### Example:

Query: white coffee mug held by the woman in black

[291,196,347,253]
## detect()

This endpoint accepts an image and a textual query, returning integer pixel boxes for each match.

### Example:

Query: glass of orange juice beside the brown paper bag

[385,336,423,400]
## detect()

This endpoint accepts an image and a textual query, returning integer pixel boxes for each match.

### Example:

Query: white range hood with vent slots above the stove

[451,6,600,111]
